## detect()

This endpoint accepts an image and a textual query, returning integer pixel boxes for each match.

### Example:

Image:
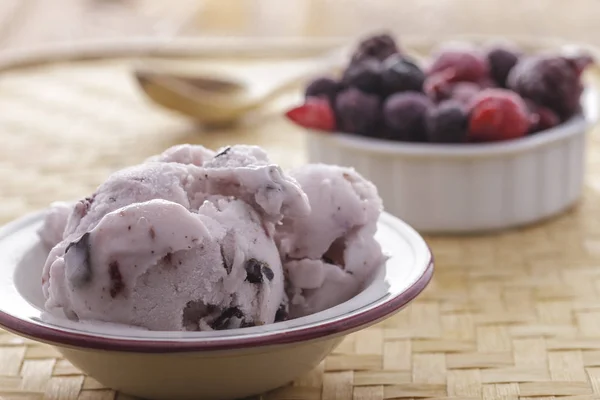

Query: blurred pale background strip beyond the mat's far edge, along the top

[0,0,600,50]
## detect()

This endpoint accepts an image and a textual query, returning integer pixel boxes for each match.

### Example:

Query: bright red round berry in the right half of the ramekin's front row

[469,89,531,142]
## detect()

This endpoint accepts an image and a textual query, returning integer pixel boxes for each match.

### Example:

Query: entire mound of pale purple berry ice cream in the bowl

[39,145,382,331]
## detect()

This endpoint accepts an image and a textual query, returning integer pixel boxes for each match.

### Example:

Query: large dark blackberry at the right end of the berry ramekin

[508,55,583,120]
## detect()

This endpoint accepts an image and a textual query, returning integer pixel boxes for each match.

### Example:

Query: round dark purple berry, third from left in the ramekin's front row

[383,92,433,142]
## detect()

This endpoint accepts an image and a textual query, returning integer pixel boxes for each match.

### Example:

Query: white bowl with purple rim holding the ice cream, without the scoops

[0,206,433,400]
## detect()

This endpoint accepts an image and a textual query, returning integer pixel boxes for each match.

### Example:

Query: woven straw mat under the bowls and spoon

[0,55,600,400]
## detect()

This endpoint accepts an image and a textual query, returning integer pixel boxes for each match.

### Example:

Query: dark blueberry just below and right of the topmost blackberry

[381,54,425,95]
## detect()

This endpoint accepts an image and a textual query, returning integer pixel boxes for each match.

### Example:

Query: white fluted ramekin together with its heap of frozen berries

[286,33,594,233]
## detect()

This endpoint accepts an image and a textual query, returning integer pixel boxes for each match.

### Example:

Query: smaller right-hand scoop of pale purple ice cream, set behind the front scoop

[276,164,385,317]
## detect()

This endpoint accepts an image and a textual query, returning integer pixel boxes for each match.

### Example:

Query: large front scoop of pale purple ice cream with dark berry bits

[43,197,285,330]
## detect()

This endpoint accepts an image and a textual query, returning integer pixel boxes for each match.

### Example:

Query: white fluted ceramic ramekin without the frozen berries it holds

[307,36,598,233]
